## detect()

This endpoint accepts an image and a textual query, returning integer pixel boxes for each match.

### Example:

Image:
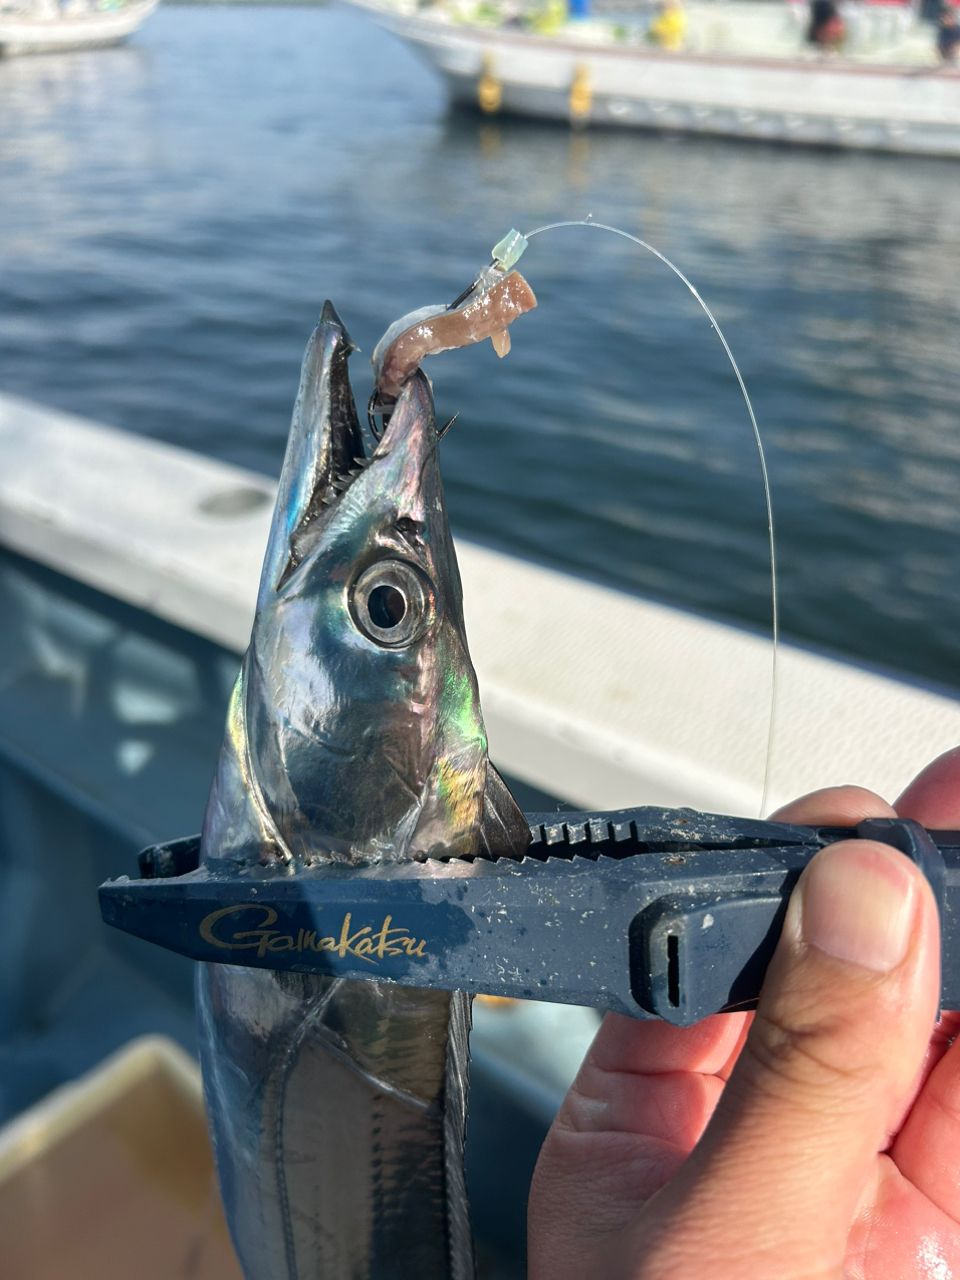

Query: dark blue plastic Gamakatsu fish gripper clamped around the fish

[100,808,960,1025]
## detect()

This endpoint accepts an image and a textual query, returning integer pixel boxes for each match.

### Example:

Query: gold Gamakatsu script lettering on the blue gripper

[200,902,428,964]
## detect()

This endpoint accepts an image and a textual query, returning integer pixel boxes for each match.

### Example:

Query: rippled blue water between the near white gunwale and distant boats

[0,8,960,686]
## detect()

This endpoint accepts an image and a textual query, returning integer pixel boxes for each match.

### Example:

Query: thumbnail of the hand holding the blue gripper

[800,841,915,973]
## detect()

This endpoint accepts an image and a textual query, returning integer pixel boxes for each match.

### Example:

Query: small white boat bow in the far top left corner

[0,0,159,56]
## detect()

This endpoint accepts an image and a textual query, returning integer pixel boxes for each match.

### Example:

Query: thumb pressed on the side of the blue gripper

[646,841,940,1280]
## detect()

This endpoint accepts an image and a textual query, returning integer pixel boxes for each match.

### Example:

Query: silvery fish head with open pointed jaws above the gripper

[204,303,527,865]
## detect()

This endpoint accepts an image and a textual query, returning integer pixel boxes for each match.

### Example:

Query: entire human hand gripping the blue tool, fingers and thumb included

[529,749,960,1280]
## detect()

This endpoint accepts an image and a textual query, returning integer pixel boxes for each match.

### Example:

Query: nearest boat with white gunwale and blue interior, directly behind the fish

[0,394,960,1280]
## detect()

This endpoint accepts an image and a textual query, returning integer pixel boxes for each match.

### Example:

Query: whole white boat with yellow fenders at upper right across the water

[352,0,960,157]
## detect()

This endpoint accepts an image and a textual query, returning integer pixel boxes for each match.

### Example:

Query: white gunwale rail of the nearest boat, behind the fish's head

[0,384,960,814]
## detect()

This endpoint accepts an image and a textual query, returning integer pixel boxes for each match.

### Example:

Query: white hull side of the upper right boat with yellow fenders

[353,3,960,156]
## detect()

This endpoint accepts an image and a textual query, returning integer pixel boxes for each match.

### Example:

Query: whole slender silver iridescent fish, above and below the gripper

[197,303,526,1280]
